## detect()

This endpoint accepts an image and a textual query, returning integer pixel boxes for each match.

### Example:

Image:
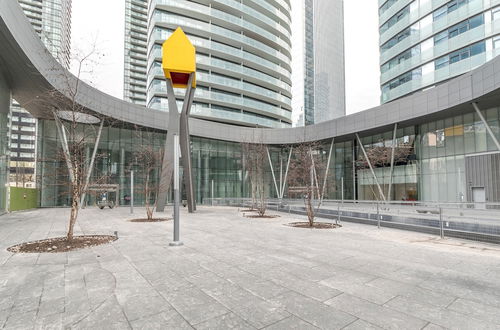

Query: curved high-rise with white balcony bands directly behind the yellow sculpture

[147,0,292,128]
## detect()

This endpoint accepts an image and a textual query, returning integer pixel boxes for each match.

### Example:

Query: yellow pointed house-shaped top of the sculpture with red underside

[162,27,196,88]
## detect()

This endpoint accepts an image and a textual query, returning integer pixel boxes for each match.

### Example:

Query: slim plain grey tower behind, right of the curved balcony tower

[303,0,345,125]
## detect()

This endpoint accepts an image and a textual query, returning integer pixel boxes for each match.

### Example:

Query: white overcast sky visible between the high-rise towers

[71,0,380,114]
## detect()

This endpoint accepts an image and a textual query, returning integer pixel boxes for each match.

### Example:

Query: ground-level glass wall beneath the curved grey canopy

[38,103,500,207]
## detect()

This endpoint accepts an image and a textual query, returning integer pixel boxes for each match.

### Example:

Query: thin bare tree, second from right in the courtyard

[241,143,268,217]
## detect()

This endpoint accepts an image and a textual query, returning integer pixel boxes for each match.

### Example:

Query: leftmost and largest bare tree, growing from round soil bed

[35,47,112,241]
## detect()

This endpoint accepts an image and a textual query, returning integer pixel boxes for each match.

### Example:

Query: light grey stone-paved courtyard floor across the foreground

[0,207,500,329]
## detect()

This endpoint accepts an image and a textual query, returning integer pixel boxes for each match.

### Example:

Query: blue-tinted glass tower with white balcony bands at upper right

[379,0,500,103]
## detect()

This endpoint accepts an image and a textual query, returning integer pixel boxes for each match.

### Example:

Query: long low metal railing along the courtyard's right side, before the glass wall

[203,198,500,244]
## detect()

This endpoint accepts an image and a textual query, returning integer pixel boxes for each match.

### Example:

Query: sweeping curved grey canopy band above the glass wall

[0,0,500,144]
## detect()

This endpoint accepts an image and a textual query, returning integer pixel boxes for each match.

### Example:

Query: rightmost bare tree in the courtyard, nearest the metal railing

[288,142,326,227]
